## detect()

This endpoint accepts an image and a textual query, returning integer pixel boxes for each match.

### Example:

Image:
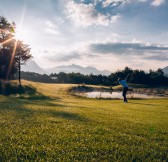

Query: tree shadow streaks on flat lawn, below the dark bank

[0,98,89,122]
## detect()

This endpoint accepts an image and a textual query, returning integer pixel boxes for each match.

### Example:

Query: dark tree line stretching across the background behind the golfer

[16,67,168,86]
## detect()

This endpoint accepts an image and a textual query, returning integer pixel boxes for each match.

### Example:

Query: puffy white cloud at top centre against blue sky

[67,1,121,27]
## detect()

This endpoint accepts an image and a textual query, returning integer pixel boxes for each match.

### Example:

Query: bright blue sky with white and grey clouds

[0,0,168,72]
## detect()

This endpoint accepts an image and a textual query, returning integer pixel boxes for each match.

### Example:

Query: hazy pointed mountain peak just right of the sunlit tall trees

[21,60,47,74]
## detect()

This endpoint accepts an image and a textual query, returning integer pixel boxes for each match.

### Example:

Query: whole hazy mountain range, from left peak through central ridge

[22,60,111,75]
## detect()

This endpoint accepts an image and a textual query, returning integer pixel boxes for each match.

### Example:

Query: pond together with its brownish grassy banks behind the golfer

[69,85,168,99]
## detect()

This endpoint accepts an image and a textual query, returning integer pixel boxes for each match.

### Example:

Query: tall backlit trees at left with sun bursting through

[0,16,31,83]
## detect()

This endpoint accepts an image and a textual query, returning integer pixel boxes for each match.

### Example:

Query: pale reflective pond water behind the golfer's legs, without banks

[77,91,163,99]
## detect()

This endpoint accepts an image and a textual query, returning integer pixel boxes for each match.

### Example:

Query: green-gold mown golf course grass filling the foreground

[0,81,168,161]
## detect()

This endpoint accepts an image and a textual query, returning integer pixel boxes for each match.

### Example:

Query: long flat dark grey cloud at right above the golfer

[89,43,168,60]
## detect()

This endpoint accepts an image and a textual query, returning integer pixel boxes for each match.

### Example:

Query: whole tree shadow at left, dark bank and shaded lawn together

[0,82,88,122]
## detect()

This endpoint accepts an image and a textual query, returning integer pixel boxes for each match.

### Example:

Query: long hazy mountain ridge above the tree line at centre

[46,64,111,75]
